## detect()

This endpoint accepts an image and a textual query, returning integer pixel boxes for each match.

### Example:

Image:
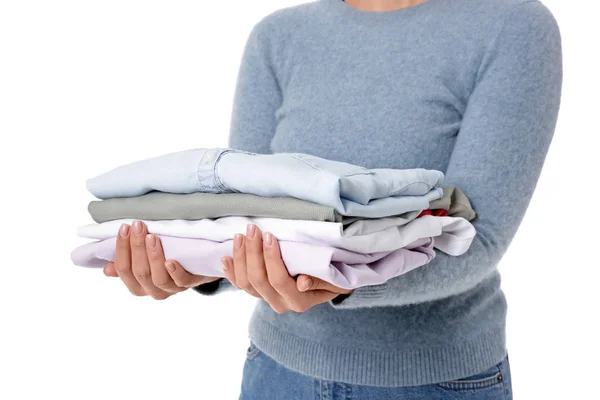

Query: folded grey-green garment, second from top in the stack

[88,187,475,225]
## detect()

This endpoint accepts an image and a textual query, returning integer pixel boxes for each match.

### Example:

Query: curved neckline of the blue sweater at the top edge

[321,0,439,23]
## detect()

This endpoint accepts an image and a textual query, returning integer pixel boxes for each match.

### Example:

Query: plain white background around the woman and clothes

[0,0,600,400]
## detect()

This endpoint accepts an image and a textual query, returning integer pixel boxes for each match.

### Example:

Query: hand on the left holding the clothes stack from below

[104,221,219,300]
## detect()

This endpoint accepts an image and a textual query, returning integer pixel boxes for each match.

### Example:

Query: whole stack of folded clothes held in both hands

[71,149,475,289]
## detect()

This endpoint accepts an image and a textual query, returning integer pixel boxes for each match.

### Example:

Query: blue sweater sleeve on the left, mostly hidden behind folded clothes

[193,13,282,295]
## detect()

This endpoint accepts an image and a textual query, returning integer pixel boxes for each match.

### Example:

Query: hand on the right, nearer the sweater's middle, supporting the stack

[223,224,351,314]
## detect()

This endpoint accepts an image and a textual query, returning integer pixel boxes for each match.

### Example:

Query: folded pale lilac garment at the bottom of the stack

[71,235,435,289]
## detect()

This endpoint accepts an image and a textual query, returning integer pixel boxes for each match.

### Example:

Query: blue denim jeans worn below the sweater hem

[239,344,512,400]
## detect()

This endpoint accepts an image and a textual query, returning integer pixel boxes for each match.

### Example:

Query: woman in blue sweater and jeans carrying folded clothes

[105,0,562,400]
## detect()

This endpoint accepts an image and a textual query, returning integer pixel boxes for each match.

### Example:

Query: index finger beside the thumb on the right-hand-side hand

[263,232,306,312]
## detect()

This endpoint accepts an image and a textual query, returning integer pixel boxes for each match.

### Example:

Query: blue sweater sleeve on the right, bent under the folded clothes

[331,1,562,308]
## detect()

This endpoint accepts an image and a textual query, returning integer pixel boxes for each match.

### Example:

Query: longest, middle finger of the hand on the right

[246,224,288,313]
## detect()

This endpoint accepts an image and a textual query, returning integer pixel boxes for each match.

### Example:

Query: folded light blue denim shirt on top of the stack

[87,148,444,218]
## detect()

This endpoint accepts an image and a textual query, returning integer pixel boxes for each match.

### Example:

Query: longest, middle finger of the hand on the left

[130,221,169,300]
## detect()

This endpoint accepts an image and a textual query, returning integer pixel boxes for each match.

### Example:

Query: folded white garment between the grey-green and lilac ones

[77,215,475,256]
